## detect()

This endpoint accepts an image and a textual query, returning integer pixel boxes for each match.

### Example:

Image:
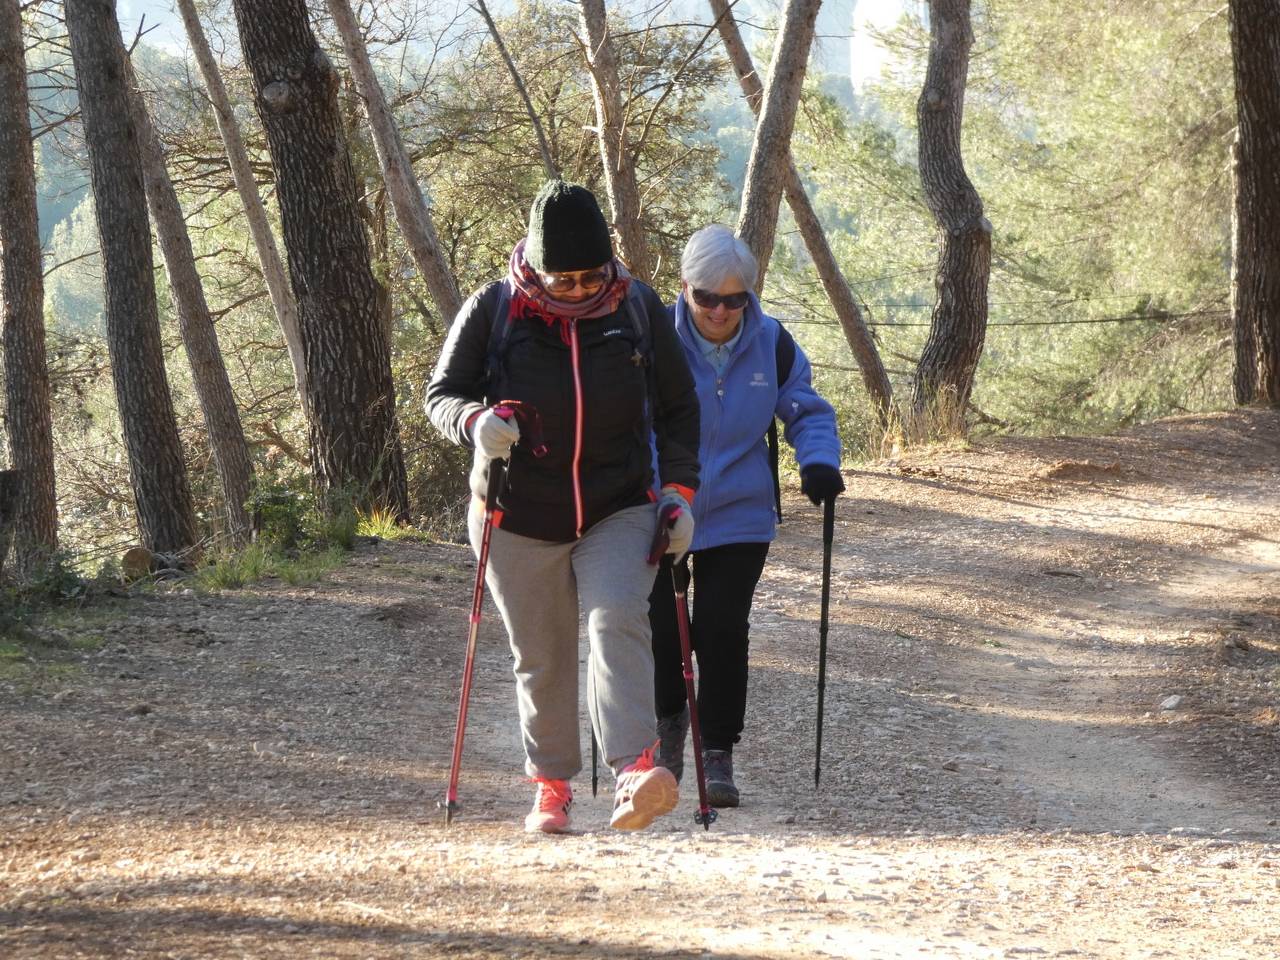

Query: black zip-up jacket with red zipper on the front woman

[426,280,699,543]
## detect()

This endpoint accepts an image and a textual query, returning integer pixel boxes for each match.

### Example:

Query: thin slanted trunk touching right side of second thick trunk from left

[125,60,253,544]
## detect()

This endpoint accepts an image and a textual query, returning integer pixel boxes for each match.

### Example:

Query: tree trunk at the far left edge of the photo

[0,0,58,575]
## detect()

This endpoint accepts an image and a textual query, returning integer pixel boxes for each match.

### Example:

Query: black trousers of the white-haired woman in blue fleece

[649,543,769,750]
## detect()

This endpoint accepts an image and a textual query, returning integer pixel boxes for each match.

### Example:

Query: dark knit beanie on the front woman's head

[525,179,613,274]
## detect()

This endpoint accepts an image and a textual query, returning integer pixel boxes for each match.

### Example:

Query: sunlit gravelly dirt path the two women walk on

[0,412,1280,960]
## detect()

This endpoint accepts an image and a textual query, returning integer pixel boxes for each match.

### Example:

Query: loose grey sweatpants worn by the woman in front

[467,500,658,780]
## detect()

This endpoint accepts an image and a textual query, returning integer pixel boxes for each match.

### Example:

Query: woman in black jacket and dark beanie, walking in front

[426,180,699,833]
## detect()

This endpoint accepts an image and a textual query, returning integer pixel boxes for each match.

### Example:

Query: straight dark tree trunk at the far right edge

[1228,0,1280,404]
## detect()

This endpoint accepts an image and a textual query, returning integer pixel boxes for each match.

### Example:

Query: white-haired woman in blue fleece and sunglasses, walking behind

[649,224,845,806]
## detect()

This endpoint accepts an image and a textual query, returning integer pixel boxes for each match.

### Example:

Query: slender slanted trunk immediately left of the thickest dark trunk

[177,0,311,422]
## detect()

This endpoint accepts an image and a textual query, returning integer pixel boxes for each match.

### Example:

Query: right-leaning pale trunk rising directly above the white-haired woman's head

[737,0,822,293]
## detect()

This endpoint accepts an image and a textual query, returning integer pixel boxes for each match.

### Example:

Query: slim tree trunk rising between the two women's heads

[579,0,653,280]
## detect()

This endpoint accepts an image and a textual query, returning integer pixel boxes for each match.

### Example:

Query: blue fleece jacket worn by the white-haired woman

[667,294,840,550]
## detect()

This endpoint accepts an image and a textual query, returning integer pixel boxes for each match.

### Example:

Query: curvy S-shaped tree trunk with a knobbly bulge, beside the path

[911,0,991,435]
